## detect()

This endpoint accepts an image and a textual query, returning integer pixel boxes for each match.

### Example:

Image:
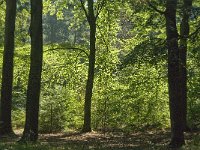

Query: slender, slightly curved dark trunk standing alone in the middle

[82,0,96,132]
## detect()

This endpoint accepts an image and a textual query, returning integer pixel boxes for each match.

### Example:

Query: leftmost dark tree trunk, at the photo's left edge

[0,0,16,135]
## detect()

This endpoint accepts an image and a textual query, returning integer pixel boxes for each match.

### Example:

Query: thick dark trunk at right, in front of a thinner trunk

[165,0,184,147]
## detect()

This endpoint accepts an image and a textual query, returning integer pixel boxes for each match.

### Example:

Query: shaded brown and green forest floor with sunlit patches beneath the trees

[0,130,200,150]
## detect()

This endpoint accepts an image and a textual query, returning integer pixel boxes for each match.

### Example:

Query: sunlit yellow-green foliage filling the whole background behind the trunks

[0,0,200,132]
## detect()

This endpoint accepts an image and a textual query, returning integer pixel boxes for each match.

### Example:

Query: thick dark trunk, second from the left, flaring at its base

[21,0,43,141]
